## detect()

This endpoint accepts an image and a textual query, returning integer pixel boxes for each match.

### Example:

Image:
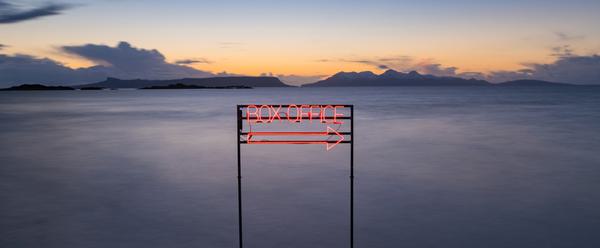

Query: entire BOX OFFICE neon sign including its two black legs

[236,104,354,248]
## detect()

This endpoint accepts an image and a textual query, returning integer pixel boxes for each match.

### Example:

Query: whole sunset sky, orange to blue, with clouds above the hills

[0,0,600,84]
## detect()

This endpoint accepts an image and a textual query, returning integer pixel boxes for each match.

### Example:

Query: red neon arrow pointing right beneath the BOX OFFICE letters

[246,126,344,151]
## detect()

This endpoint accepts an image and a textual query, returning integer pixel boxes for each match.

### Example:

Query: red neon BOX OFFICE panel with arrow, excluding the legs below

[238,104,353,151]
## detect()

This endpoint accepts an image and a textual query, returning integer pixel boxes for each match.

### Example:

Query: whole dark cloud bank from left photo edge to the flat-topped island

[0,42,220,86]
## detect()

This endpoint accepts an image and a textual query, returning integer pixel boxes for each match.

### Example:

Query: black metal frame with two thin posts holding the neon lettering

[236,104,354,248]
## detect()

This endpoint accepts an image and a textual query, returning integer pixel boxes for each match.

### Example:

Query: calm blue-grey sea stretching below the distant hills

[0,87,600,248]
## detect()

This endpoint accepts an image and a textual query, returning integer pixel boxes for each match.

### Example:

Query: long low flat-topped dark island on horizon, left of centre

[78,77,289,89]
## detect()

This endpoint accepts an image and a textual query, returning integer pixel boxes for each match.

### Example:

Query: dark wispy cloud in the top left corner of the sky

[0,0,72,24]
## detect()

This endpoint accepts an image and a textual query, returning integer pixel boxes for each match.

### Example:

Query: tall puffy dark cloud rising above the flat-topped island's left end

[62,42,213,79]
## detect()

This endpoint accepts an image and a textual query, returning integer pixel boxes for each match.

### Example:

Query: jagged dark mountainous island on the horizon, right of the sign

[303,70,491,87]
